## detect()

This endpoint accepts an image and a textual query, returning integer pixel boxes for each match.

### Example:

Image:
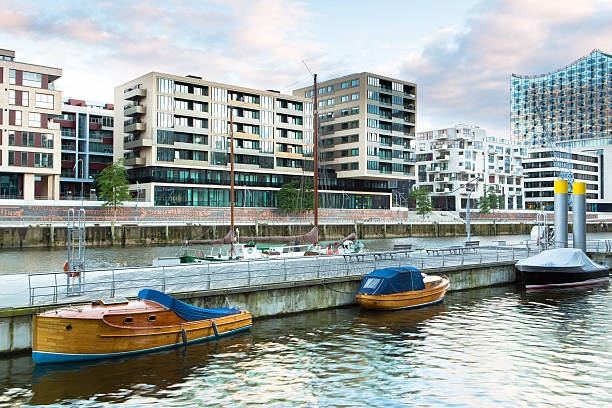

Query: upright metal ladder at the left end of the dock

[64,208,85,296]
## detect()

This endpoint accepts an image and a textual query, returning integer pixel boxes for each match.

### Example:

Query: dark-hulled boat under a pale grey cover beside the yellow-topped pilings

[515,248,610,289]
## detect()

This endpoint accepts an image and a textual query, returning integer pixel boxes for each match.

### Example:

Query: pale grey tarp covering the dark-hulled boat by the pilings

[516,248,608,272]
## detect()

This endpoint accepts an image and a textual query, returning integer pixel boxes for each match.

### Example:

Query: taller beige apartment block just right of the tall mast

[293,72,417,208]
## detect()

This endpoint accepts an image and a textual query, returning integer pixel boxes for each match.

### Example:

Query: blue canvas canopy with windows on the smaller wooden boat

[358,267,425,295]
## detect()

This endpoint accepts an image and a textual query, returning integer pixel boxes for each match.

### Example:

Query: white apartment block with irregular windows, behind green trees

[416,125,526,211]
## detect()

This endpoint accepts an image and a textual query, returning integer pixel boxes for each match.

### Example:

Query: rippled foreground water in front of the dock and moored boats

[0,286,612,407]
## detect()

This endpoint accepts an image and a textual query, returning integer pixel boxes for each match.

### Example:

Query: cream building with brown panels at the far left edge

[0,49,62,200]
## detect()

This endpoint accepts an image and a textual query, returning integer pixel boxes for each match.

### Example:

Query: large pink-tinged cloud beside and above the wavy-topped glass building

[398,0,612,136]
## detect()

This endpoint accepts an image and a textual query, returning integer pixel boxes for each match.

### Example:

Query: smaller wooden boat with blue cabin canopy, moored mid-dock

[357,267,450,310]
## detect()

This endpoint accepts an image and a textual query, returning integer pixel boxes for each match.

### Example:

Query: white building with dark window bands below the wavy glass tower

[523,148,603,211]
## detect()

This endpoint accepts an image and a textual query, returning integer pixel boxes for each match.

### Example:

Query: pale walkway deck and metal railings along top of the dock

[0,240,612,308]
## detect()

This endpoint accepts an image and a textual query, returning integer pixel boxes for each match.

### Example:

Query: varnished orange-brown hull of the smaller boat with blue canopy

[356,276,450,310]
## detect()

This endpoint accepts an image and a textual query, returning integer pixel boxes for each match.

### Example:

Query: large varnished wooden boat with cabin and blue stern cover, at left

[32,289,252,364]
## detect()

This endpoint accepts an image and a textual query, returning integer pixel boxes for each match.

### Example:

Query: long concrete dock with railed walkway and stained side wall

[0,241,612,353]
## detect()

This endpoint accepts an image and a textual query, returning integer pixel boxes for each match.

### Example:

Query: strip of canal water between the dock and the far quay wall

[0,234,536,274]
